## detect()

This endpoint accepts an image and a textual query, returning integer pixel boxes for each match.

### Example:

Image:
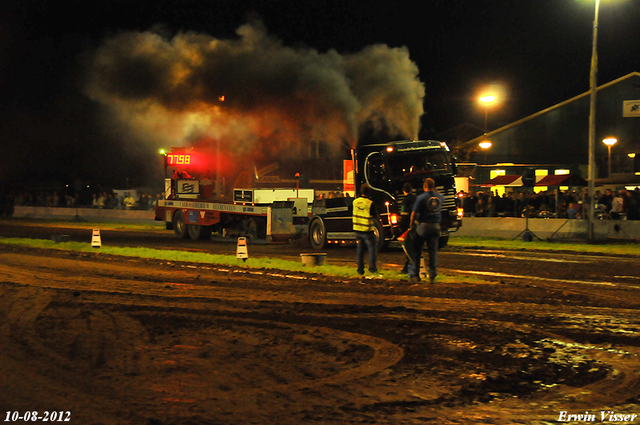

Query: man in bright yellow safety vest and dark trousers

[353,183,378,276]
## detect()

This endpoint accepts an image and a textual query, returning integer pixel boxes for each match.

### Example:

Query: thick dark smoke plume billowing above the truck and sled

[87,24,424,154]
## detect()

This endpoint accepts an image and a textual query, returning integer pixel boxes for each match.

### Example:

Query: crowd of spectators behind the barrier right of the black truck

[458,187,640,220]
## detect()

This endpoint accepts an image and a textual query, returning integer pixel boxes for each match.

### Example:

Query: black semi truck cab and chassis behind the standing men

[307,140,463,250]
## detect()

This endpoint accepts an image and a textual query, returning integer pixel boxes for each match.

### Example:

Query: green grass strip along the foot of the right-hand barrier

[449,236,640,255]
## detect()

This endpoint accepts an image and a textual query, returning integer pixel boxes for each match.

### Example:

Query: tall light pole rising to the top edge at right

[587,0,600,242]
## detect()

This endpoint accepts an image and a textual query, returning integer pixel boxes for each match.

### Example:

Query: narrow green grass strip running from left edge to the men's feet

[0,237,486,283]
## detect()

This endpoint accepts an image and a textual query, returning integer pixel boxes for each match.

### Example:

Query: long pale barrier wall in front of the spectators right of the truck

[451,217,640,242]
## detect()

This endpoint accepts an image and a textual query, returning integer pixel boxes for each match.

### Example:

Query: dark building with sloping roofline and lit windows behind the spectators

[445,72,640,190]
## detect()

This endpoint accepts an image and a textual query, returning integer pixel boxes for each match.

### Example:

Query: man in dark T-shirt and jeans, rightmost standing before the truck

[409,178,444,283]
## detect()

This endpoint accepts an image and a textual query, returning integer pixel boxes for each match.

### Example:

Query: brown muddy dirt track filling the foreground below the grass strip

[0,224,640,425]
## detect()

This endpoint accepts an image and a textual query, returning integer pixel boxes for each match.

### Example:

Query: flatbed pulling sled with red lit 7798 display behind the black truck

[155,148,314,241]
